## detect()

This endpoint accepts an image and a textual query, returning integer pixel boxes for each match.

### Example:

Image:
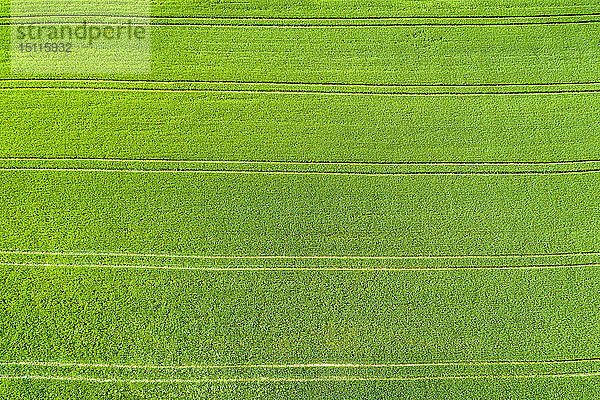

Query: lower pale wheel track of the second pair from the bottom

[0,262,600,272]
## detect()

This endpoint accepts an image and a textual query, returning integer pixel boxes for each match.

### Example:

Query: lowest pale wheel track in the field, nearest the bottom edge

[0,372,600,384]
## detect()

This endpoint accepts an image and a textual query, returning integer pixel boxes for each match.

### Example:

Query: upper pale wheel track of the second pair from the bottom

[0,250,600,260]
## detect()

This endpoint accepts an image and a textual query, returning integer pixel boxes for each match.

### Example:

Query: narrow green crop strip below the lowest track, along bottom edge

[0,378,599,400]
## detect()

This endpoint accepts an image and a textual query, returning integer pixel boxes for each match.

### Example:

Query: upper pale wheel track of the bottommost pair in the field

[0,358,600,369]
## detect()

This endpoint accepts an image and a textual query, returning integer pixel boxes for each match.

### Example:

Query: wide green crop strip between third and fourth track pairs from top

[0,171,600,256]
